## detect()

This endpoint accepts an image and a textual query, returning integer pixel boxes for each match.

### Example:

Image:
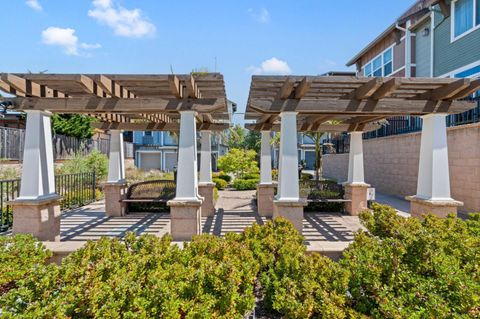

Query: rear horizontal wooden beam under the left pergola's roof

[91,122,230,131]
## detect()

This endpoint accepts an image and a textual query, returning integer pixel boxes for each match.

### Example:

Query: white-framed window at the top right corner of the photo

[452,0,480,40]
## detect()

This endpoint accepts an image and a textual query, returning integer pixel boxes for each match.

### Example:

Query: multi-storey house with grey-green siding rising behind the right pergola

[347,0,480,138]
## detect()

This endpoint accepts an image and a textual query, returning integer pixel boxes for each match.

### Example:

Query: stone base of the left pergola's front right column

[167,199,202,241]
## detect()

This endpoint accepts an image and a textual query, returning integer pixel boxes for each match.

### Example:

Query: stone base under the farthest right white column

[405,196,463,218]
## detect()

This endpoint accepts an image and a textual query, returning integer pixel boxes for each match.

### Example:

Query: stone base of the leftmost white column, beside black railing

[11,195,61,241]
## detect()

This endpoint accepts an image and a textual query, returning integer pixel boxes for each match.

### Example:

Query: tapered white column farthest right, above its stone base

[416,114,452,200]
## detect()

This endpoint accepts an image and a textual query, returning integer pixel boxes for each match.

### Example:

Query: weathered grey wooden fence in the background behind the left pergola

[0,127,133,161]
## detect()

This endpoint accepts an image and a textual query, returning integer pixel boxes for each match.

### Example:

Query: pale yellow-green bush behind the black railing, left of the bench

[58,150,108,181]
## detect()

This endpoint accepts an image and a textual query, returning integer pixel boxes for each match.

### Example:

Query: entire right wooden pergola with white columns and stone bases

[245,76,480,231]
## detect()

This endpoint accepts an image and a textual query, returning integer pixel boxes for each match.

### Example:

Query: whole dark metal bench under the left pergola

[122,180,176,212]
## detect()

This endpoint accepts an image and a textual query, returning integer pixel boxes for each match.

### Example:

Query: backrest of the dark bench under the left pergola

[127,180,176,200]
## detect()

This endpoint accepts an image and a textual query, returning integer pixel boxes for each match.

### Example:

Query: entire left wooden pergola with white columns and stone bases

[0,73,230,240]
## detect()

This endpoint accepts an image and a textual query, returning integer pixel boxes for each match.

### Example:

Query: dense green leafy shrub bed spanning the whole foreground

[0,205,480,318]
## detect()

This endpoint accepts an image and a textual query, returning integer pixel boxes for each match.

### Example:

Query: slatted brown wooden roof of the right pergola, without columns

[245,76,480,132]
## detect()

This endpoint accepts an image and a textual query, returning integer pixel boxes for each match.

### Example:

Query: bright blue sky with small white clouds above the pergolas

[0,0,414,122]
